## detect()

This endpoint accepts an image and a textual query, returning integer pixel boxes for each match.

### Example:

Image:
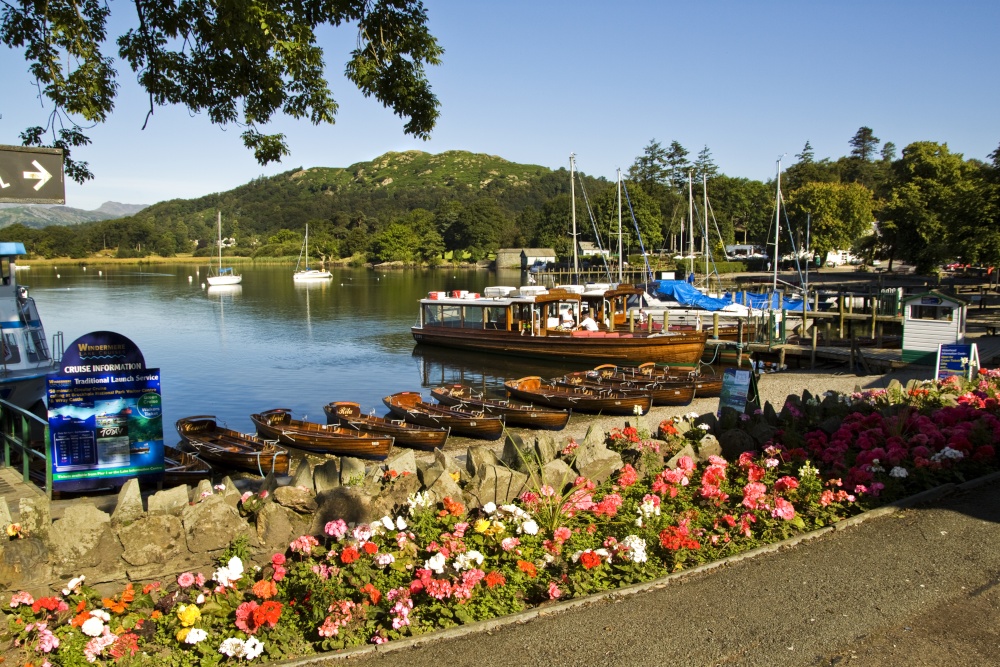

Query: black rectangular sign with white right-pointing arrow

[0,146,66,204]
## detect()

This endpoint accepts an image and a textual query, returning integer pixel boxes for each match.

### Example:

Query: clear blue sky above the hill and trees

[0,0,1000,209]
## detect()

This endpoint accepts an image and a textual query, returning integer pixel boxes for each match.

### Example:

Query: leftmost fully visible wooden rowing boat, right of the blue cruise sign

[176,415,289,477]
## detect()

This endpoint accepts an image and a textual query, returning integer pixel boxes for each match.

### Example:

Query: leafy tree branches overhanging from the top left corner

[0,0,444,182]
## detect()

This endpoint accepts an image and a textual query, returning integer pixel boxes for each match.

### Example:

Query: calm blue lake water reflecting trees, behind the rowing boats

[27,262,587,443]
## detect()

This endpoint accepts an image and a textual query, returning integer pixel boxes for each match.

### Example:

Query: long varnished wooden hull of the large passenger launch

[411,325,708,363]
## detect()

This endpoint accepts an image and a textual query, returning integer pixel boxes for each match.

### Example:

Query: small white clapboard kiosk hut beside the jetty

[902,291,968,366]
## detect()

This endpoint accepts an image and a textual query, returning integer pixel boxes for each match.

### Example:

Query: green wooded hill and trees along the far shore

[0,136,1000,271]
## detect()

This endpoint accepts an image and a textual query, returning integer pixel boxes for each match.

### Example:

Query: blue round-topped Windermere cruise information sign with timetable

[48,331,164,491]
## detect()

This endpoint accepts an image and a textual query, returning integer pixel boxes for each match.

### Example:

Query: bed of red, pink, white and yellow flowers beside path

[3,371,1000,665]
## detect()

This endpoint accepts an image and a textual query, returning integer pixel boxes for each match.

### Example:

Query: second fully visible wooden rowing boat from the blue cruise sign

[250,408,392,461]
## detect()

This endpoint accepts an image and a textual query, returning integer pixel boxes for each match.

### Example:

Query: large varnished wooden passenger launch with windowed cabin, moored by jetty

[411,288,708,363]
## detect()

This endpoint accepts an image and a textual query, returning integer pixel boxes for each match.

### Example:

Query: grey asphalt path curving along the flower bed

[290,477,1000,667]
